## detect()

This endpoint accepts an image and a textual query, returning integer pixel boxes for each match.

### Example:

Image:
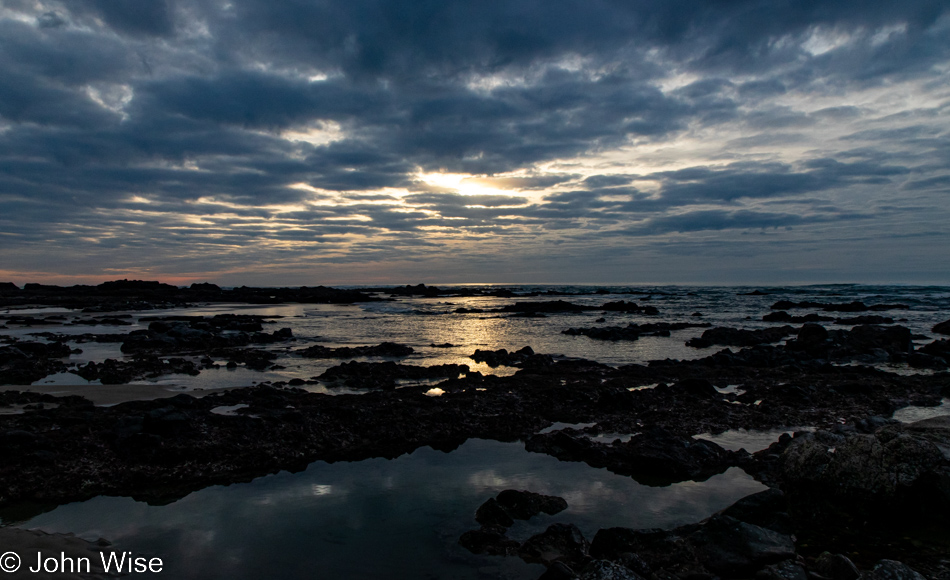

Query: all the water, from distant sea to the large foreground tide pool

[0,285,950,579]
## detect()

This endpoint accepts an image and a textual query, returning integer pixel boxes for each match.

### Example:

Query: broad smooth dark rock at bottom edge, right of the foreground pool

[688,515,795,577]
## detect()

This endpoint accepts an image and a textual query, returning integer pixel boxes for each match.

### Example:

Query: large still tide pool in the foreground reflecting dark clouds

[22,440,764,580]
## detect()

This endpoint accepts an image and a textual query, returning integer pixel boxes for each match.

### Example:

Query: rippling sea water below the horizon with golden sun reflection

[0,285,950,392]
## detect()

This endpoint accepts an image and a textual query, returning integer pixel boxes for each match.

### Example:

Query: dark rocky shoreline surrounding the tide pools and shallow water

[0,287,950,580]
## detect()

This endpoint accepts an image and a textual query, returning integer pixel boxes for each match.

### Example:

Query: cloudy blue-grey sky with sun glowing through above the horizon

[0,0,950,285]
